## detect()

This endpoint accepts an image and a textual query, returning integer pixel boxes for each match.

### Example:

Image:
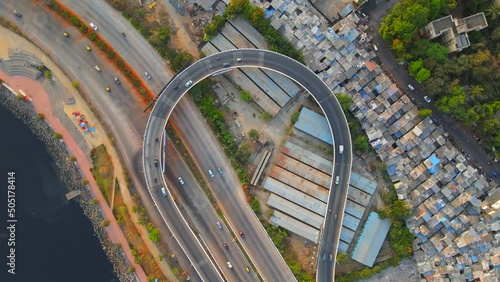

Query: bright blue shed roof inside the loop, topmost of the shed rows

[294,107,333,145]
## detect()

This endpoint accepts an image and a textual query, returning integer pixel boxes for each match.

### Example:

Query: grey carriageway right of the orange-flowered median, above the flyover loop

[62,0,173,94]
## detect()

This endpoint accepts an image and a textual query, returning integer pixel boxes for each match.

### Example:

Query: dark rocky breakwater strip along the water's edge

[0,85,138,281]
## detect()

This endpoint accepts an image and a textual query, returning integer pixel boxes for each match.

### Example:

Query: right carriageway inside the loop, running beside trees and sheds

[173,97,293,281]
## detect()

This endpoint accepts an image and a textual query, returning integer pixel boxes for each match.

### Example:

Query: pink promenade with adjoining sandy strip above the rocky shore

[0,27,147,281]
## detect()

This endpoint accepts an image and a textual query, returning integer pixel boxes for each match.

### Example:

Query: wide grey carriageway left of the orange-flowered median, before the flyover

[0,0,147,135]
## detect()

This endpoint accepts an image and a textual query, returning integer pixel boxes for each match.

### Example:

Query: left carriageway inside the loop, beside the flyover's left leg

[165,138,256,281]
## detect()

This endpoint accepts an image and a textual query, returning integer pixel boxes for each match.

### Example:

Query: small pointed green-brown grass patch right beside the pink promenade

[90,145,114,205]
